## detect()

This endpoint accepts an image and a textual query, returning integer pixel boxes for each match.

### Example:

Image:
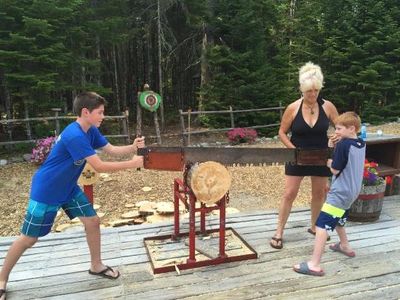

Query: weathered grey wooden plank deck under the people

[0,196,400,300]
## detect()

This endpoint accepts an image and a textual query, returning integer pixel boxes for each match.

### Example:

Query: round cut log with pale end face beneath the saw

[187,161,232,204]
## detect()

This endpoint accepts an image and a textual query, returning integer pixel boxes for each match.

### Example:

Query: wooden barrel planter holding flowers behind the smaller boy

[348,183,386,222]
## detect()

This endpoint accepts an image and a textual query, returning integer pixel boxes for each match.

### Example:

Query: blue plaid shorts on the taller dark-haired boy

[21,192,96,237]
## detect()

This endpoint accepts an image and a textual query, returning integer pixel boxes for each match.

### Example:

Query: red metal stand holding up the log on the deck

[144,179,257,274]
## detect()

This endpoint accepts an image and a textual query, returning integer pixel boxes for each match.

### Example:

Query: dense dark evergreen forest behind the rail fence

[0,0,400,137]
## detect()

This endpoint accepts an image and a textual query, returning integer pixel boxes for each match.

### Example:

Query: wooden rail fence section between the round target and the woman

[179,103,285,146]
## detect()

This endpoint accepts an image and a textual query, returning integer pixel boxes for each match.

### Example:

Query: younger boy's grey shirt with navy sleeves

[326,138,365,209]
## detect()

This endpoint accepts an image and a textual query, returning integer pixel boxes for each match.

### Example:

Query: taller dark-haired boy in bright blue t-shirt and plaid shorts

[0,92,144,299]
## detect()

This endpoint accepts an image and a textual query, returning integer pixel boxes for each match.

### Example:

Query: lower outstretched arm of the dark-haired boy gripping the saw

[86,154,143,173]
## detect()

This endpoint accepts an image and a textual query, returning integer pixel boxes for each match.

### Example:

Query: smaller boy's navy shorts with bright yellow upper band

[315,203,349,231]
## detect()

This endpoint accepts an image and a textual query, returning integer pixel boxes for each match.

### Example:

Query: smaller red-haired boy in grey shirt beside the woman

[293,112,365,276]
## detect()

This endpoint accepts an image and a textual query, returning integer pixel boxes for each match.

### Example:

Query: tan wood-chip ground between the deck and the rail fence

[0,123,400,236]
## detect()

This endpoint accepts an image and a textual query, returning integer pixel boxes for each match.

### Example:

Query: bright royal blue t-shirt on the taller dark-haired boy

[30,122,108,205]
